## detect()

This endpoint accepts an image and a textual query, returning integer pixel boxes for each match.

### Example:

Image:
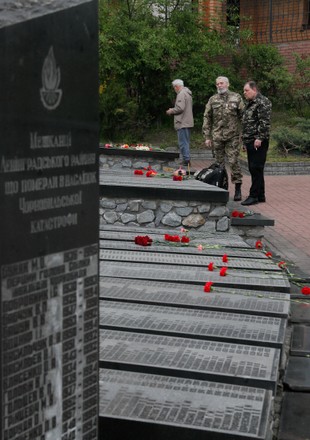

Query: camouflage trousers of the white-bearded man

[212,136,243,184]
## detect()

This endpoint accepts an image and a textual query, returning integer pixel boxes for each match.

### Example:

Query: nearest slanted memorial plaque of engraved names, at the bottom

[99,369,271,440]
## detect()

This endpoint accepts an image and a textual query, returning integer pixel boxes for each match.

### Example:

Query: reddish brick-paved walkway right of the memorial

[192,160,310,278]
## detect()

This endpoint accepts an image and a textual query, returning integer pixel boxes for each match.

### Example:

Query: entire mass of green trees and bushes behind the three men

[99,0,310,142]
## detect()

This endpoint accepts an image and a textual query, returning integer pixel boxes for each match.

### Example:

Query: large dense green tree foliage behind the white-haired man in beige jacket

[99,0,229,137]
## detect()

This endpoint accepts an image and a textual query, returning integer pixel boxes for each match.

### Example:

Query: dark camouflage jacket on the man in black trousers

[242,93,272,142]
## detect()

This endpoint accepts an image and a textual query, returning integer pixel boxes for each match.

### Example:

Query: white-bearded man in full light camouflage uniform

[202,76,244,201]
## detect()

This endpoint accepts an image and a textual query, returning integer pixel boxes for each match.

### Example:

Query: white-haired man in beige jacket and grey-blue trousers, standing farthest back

[166,79,194,165]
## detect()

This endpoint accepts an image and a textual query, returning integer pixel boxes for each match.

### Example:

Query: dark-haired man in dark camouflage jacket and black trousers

[241,81,272,206]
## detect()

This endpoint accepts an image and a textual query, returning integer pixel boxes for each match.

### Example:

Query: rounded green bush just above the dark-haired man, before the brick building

[233,44,293,104]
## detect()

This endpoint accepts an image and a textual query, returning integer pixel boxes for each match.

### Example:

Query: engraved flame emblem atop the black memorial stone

[40,46,62,110]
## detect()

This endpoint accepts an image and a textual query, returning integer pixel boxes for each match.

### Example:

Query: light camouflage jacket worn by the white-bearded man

[202,91,244,141]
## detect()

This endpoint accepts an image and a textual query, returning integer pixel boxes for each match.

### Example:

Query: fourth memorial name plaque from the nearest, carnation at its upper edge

[100,278,290,317]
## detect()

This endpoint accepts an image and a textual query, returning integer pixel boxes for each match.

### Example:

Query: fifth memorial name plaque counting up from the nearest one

[100,261,290,293]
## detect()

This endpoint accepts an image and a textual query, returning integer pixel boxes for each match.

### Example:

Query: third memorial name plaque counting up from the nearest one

[100,300,286,348]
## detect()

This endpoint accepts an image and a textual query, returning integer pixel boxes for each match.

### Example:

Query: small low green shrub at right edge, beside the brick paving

[272,118,310,156]
